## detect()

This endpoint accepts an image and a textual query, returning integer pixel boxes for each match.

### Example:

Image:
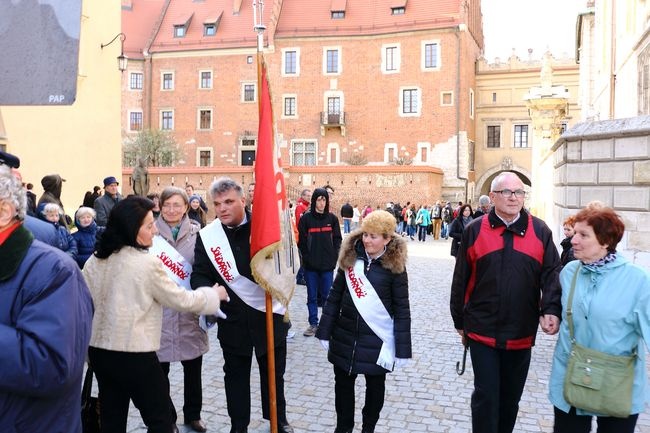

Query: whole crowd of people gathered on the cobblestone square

[0,153,650,433]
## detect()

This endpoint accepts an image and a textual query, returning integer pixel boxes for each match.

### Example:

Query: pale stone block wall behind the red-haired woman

[552,116,650,266]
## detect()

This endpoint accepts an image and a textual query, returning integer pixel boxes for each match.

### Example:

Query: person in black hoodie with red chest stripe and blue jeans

[298,188,343,337]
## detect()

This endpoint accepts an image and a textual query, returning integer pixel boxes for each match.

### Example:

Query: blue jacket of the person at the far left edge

[0,227,93,433]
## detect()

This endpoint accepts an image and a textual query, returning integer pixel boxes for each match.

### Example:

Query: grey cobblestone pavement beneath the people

[128,239,650,433]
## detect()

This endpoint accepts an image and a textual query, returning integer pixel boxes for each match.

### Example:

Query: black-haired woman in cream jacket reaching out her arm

[83,196,227,433]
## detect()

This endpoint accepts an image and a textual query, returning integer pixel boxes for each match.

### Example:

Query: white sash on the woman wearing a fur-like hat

[345,259,395,371]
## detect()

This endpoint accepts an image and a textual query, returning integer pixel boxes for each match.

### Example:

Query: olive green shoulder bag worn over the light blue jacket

[564,267,637,418]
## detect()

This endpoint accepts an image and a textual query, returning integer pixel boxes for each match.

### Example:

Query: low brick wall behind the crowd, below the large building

[121,165,443,216]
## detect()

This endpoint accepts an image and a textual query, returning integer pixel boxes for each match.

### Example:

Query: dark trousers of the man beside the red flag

[223,346,287,429]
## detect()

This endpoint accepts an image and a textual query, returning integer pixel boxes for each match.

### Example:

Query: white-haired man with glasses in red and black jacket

[450,172,562,433]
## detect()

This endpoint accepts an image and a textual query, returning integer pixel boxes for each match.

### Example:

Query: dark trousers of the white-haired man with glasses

[469,340,530,433]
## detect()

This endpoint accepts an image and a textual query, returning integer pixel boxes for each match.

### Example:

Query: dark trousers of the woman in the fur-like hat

[334,366,386,432]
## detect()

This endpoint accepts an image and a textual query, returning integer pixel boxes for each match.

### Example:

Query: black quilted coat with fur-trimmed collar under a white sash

[316,230,411,375]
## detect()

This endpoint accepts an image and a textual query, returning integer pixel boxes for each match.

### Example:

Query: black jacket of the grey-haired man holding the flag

[190,214,288,356]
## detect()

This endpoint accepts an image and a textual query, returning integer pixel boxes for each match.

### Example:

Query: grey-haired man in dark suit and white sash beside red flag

[190,177,293,433]
